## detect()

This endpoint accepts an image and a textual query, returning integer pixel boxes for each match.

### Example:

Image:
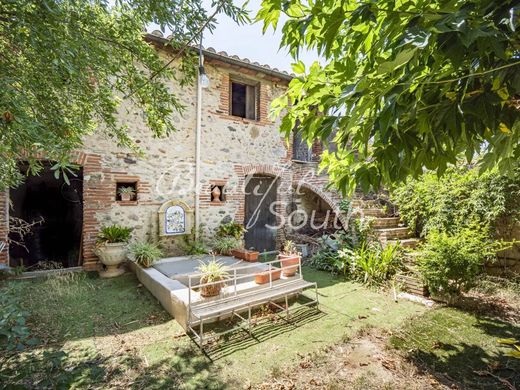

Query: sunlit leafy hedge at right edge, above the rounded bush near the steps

[392,167,520,236]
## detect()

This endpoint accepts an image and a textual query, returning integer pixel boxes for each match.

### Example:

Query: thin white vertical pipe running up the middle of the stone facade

[195,33,209,238]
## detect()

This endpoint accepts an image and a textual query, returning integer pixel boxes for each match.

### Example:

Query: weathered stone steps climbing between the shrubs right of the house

[351,199,428,296]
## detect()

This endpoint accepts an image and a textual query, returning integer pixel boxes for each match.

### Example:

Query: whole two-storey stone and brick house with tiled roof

[0,32,348,269]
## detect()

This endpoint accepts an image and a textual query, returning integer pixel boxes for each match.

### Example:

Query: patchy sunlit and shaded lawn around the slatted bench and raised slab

[0,269,425,389]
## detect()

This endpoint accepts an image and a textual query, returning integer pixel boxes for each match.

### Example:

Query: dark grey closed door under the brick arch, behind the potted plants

[244,176,278,252]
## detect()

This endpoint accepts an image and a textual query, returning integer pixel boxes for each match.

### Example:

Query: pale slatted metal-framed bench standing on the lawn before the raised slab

[187,260,319,349]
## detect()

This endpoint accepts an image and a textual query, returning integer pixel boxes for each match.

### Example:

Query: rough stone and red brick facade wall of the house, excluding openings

[0,46,346,269]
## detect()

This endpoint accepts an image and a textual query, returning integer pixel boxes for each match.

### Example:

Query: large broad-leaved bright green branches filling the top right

[257,0,520,192]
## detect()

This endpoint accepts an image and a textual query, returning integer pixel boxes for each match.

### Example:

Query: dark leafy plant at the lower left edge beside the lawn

[0,288,37,351]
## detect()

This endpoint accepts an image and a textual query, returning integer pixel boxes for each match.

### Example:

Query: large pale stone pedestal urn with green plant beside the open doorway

[95,225,132,278]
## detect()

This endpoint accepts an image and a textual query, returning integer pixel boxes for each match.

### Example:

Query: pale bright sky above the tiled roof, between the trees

[202,0,318,72]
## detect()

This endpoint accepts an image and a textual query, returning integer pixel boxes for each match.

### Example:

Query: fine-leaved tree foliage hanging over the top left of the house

[0,0,247,189]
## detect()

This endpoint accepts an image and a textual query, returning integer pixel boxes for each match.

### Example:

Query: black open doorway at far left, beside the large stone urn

[9,162,83,270]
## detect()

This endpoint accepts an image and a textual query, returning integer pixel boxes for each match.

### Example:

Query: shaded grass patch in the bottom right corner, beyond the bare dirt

[390,307,520,389]
